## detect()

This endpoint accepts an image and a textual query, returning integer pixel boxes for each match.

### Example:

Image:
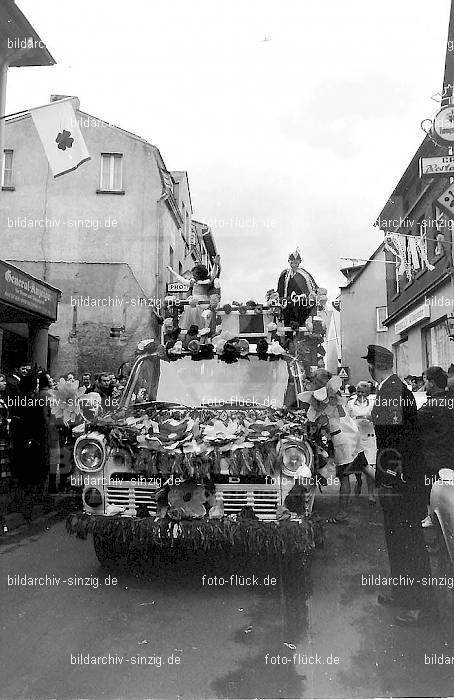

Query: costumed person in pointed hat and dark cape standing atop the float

[277,248,318,326]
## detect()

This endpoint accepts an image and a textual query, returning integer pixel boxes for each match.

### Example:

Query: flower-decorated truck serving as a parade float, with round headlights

[67,249,329,566]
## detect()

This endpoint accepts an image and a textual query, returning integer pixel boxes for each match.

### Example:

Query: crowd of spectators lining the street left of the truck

[0,362,130,534]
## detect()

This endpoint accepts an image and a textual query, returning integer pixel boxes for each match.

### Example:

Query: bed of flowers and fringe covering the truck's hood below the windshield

[92,408,325,479]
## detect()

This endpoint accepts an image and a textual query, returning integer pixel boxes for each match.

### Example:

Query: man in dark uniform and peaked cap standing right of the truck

[363,345,434,625]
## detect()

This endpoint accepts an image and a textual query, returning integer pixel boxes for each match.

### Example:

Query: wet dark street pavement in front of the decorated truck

[0,489,454,700]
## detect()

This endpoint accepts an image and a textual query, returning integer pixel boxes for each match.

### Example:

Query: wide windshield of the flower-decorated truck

[125,355,290,408]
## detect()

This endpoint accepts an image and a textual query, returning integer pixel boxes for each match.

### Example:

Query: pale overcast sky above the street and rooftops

[7,0,450,301]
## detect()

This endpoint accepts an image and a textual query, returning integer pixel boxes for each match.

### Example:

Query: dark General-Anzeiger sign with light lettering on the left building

[0,260,58,321]
